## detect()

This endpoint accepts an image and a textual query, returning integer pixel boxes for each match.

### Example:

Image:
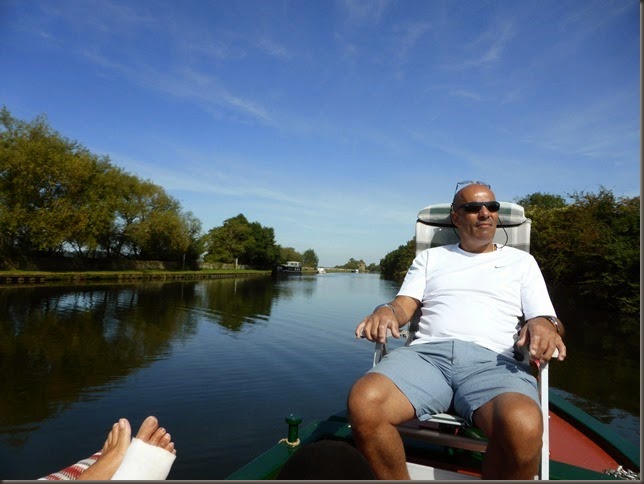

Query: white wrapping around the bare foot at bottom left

[112,438,177,481]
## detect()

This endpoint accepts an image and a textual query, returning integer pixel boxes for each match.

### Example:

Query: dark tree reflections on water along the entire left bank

[0,277,328,427]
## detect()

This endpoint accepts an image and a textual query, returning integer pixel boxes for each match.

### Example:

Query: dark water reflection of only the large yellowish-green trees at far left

[0,284,194,426]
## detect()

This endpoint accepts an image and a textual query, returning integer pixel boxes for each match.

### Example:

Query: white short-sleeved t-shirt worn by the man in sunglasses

[398,244,556,357]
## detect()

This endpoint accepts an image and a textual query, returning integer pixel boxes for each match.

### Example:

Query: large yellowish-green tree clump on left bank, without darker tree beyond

[0,107,201,265]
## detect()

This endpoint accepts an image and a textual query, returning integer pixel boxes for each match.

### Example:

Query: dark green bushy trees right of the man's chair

[530,187,640,313]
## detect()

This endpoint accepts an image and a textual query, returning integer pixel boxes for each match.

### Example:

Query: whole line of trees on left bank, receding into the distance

[0,107,375,270]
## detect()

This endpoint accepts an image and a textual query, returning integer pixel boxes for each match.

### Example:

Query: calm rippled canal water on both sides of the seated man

[0,273,640,480]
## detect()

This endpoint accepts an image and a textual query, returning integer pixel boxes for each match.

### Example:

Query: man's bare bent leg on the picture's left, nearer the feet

[347,373,416,480]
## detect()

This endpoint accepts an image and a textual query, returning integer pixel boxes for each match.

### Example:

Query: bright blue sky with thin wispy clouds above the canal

[0,0,640,266]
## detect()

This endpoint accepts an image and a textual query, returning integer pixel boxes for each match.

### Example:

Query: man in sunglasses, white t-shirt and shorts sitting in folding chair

[348,182,566,479]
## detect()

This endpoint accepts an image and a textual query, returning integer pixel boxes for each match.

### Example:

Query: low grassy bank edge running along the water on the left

[0,269,270,285]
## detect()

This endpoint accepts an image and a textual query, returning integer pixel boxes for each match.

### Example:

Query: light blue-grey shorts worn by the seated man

[369,340,539,424]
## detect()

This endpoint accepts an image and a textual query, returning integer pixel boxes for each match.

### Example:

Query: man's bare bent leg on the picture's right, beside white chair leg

[472,393,543,479]
